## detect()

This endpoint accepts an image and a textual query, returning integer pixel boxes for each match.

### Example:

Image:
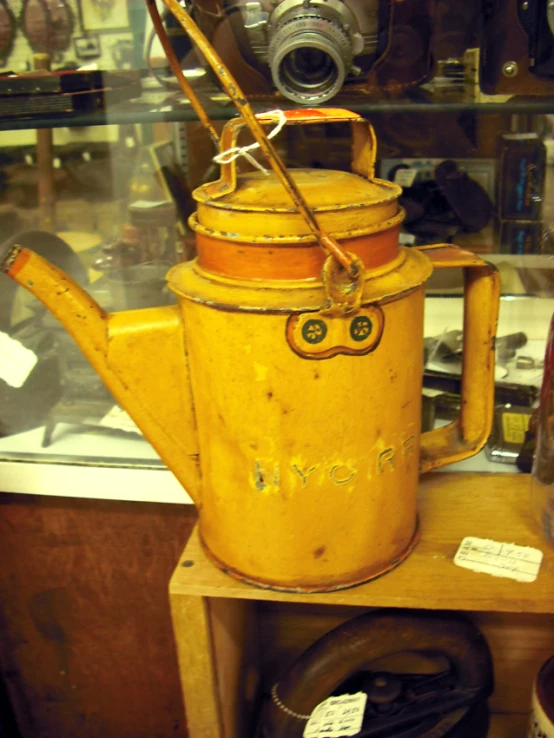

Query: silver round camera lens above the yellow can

[269,16,352,105]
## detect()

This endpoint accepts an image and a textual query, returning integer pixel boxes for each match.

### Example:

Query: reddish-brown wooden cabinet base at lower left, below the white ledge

[0,493,196,738]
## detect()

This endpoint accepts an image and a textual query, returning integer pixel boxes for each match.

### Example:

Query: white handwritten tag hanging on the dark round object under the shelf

[304,692,367,738]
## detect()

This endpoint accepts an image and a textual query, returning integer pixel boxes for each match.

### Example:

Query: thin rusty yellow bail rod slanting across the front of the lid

[151,0,359,279]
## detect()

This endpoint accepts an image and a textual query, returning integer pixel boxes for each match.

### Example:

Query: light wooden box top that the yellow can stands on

[170,473,554,613]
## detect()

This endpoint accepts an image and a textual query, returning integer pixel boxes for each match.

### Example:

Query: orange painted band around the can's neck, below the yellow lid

[196,226,400,280]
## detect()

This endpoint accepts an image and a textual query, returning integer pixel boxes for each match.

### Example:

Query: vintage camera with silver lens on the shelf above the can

[201,0,434,106]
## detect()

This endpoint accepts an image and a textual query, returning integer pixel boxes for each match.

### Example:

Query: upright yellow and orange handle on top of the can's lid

[210,108,377,197]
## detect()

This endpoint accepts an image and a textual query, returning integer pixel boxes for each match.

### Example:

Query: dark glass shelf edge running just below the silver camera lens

[0,79,554,131]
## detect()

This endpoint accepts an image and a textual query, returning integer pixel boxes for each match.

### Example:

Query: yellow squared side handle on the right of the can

[418,244,500,472]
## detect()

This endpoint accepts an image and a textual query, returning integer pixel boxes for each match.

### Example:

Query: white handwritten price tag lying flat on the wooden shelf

[454,536,543,582]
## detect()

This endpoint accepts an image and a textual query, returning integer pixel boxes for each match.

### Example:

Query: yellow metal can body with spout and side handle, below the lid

[2,242,497,589]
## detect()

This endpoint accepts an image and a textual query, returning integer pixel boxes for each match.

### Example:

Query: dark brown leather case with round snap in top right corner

[480,0,554,95]
